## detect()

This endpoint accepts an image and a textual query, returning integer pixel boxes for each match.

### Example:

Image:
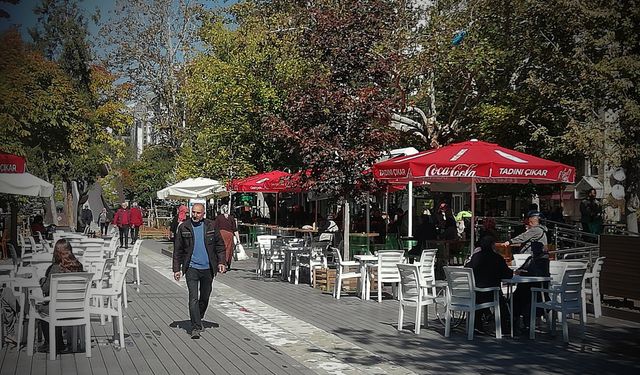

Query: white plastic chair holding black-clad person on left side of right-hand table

[444,266,502,340]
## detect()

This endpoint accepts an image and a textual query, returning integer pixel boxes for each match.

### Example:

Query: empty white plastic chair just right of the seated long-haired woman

[89,266,129,349]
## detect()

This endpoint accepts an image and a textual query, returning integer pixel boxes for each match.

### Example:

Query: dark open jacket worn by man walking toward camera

[173,219,225,276]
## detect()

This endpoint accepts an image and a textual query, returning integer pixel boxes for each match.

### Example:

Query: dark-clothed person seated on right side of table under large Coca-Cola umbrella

[513,242,549,332]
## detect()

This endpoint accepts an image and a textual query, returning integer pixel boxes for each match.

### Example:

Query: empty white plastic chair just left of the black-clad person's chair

[396,264,436,334]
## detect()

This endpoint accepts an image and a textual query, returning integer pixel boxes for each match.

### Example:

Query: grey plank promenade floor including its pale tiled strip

[0,241,640,375]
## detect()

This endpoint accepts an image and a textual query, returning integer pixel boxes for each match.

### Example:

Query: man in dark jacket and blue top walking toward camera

[173,203,227,339]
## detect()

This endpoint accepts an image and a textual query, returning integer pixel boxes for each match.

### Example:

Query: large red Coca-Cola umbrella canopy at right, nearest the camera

[373,140,576,184]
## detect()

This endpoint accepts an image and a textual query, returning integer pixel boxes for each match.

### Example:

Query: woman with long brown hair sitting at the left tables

[38,238,84,352]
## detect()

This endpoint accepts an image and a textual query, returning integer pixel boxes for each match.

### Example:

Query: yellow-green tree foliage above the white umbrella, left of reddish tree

[177,2,309,180]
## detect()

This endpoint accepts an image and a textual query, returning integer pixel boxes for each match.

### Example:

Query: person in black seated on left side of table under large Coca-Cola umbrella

[465,236,513,331]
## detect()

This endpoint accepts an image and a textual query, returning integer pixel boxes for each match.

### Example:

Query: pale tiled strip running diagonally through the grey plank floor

[140,246,414,375]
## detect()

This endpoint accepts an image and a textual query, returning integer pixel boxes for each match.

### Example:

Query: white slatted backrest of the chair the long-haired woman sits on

[49,272,93,321]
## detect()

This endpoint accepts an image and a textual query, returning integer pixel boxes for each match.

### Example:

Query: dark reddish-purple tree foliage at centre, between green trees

[266,0,415,196]
